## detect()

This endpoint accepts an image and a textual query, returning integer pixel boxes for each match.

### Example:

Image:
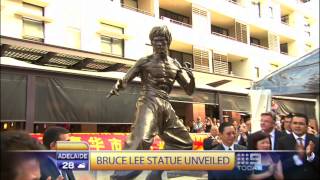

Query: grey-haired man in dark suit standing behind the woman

[248,112,285,150]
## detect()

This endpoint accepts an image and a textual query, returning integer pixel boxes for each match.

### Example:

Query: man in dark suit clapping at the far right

[278,114,319,179]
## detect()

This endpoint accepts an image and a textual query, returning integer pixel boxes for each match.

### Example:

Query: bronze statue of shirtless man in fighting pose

[108,26,195,179]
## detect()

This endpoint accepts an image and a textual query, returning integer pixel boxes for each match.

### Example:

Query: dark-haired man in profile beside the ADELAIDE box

[40,127,75,180]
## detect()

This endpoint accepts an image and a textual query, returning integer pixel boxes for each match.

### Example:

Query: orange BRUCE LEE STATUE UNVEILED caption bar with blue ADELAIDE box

[56,151,235,170]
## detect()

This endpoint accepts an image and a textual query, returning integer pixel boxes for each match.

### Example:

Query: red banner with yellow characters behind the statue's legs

[31,133,208,150]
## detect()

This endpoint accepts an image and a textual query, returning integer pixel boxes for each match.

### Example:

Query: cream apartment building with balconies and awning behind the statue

[1,0,319,131]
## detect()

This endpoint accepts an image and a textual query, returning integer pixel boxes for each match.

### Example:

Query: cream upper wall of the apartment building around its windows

[1,0,319,88]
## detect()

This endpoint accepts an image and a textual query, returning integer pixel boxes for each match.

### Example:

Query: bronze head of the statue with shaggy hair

[149,26,172,57]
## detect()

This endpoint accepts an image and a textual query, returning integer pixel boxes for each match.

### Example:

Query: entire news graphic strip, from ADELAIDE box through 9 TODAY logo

[12,150,297,172]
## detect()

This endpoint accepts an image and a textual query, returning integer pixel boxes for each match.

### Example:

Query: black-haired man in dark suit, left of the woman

[208,122,247,180]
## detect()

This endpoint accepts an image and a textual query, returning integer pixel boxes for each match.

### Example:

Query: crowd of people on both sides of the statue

[1,112,320,180]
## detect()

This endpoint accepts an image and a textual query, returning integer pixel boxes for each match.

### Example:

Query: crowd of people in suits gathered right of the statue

[204,112,319,180]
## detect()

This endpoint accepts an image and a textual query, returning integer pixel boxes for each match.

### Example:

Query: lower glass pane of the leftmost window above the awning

[23,19,44,39]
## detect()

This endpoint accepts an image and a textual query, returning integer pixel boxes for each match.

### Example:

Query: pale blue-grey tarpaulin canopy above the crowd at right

[252,48,319,98]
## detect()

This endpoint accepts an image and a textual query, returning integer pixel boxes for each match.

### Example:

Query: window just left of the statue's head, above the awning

[101,23,124,57]
